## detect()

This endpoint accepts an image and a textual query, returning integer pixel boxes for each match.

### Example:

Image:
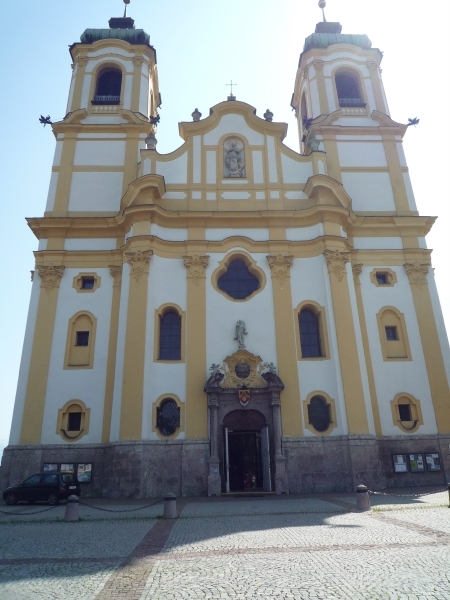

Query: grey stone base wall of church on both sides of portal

[0,435,450,498]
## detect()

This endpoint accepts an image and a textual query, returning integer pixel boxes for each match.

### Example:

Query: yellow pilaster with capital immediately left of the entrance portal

[183,254,209,439]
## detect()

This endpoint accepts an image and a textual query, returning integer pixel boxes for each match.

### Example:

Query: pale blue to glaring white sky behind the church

[0,0,450,451]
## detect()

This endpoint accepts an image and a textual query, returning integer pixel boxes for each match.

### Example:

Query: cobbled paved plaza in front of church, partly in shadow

[0,491,450,600]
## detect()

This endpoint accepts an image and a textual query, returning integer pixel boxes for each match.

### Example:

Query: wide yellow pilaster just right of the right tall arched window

[324,250,369,434]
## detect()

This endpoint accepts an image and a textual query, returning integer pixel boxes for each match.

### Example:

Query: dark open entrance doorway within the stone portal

[228,431,263,491]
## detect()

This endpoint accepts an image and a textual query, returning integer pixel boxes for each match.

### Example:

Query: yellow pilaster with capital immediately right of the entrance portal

[267,254,303,437]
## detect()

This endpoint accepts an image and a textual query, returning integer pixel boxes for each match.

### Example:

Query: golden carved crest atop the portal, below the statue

[219,350,268,389]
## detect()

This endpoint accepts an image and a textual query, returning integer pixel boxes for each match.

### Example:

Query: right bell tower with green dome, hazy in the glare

[292,0,417,215]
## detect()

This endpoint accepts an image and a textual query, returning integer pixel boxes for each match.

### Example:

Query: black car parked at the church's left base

[3,473,80,505]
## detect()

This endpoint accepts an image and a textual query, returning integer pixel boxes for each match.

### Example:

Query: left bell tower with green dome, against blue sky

[46,1,161,217]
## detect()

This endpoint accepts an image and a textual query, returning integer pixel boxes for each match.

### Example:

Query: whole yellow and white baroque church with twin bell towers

[1,1,450,498]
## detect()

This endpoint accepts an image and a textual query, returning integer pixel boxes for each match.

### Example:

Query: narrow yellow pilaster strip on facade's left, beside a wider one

[102,265,122,444]
